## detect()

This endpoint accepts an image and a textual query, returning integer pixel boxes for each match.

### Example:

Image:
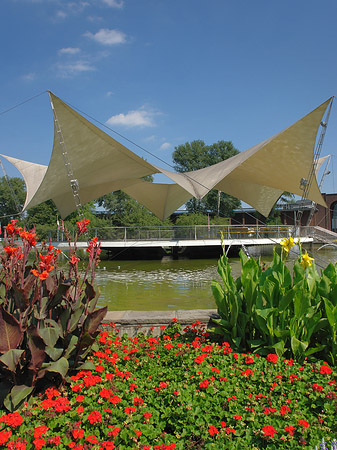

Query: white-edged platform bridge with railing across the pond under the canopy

[55,225,315,257]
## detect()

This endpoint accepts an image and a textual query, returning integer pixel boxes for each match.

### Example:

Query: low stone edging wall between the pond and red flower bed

[103,309,219,336]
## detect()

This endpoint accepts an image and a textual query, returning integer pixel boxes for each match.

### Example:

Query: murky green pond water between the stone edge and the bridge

[96,246,337,311]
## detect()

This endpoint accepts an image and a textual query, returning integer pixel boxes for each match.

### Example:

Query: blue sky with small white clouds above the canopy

[0,0,337,197]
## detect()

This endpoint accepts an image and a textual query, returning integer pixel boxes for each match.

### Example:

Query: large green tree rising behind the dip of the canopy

[172,140,241,217]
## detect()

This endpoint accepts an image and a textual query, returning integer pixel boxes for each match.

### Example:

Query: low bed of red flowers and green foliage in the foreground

[0,320,337,450]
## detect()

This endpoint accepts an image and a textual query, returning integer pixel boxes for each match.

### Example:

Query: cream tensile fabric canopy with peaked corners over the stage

[2,93,331,219]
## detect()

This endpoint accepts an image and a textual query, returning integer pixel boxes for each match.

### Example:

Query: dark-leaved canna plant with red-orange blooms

[0,219,107,411]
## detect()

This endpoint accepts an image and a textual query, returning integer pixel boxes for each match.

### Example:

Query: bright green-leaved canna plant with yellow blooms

[212,237,337,364]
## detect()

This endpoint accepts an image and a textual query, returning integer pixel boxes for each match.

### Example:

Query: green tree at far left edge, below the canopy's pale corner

[0,176,26,221]
